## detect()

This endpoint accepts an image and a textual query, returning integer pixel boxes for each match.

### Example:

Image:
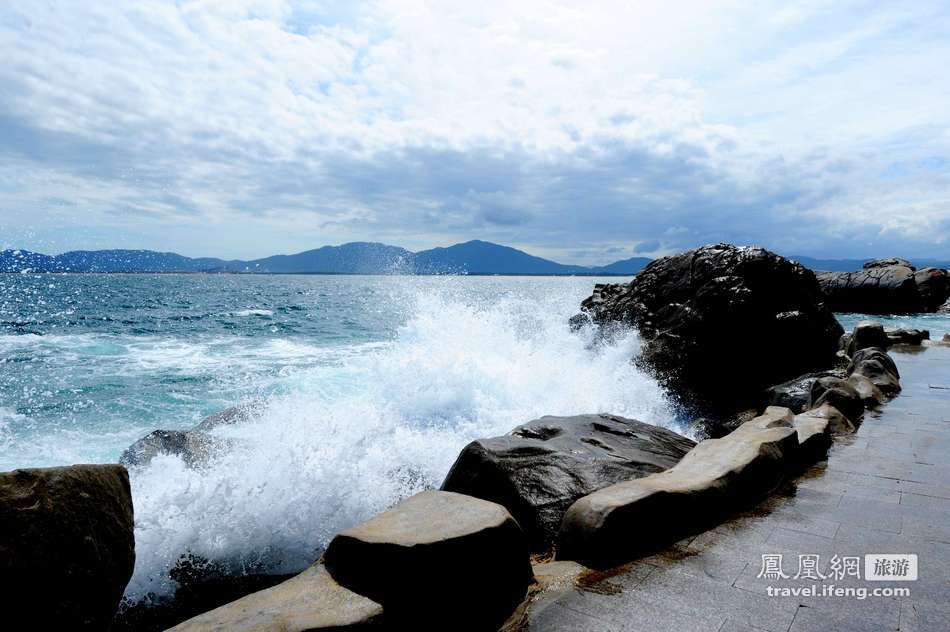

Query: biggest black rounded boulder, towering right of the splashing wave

[582,244,843,416]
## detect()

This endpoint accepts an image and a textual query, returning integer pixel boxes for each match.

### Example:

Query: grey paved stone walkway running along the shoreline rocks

[526,347,950,632]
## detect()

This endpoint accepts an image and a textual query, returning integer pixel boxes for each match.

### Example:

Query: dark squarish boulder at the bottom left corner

[0,465,135,630]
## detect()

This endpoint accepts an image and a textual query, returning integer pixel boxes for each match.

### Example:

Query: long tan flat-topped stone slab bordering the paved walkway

[556,406,799,566]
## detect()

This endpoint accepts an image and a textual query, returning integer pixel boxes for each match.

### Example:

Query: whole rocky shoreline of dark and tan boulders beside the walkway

[0,244,950,631]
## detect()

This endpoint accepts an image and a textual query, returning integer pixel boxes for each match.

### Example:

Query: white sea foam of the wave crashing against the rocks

[128,284,673,598]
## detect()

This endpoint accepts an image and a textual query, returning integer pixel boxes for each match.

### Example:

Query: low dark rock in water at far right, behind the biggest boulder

[818,259,950,314]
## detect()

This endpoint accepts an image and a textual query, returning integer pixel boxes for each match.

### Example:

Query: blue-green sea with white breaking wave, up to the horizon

[0,274,950,601]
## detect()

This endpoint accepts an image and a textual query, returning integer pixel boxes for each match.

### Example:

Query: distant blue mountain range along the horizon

[0,240,950,276]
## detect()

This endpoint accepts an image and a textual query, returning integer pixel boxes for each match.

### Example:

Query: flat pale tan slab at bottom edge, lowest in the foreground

[171,564,383,632]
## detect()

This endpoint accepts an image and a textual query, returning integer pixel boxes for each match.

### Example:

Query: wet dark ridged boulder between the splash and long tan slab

[442,415,696,550]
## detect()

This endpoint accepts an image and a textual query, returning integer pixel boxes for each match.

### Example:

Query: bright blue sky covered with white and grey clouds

[0,0,950,264]
